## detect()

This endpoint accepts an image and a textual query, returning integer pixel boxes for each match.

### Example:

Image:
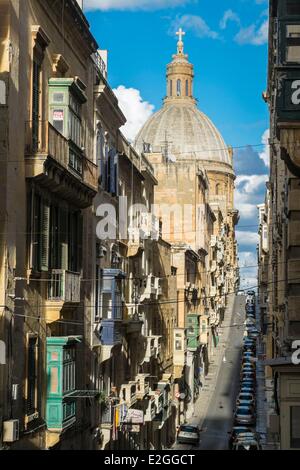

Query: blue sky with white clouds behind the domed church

[84,0,268,285]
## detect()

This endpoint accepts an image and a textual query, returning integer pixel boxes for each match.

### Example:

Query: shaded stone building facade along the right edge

[259,0,300,450]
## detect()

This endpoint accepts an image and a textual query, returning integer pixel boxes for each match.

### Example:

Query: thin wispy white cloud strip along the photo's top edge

[84,0,192,11]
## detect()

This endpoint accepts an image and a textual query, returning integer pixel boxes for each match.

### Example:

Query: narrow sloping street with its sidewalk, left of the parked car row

[175,296,245,450]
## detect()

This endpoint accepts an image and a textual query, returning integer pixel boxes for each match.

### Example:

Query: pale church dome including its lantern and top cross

[135,28,232,167]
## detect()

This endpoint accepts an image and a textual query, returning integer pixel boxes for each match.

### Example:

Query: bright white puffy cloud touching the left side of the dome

[113,85,154,141]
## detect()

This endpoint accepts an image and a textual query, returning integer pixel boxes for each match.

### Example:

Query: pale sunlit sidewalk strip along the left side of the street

[189,294,235,428]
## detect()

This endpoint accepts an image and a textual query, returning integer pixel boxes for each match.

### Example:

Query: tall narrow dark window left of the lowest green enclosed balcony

[26,336,37,416]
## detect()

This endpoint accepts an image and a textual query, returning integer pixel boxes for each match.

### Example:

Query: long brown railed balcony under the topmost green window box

[25,121,98,208]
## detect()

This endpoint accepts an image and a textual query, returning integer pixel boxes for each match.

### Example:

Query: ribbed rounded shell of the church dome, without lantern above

[135,103,232,166]
